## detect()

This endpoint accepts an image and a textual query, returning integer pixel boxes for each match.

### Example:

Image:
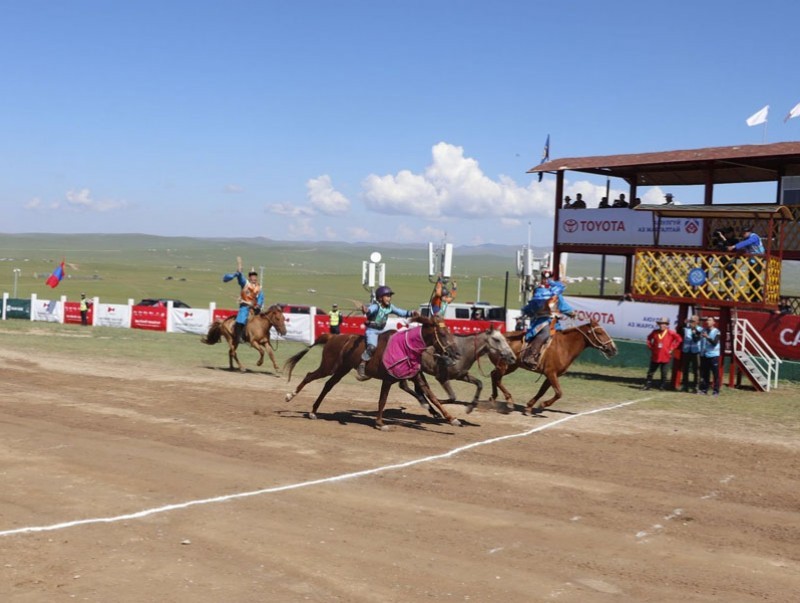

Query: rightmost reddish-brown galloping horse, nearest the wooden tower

[489,320,617,412]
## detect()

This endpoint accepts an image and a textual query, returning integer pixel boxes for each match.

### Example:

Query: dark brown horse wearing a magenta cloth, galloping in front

[283,316,461,431]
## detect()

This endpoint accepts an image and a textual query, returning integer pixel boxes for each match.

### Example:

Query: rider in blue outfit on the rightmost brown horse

[520,270,575,370]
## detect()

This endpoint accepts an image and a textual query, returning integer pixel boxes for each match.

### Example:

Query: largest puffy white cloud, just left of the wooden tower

[362,142,554,219]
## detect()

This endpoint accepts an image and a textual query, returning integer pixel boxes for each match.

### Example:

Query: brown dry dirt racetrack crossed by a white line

[0,350,800,603]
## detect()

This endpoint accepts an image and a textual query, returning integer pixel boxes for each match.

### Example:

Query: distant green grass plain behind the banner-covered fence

[0,234,800,310]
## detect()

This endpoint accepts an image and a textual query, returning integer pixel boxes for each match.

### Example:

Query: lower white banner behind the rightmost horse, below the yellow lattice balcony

[563,296,678,341]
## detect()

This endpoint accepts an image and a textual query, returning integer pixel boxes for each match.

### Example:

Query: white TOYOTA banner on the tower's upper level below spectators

[558,208,703,247]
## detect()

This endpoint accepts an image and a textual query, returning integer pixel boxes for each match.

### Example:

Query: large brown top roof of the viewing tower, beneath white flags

[528,142,800,186]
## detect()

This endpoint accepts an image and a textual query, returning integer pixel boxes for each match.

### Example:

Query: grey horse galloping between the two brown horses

[400,325,517,412]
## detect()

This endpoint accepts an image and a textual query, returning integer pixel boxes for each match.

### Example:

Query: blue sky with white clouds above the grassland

[0,0,800,245]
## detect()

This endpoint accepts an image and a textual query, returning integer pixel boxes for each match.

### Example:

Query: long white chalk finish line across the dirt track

[0,398,650,536]
